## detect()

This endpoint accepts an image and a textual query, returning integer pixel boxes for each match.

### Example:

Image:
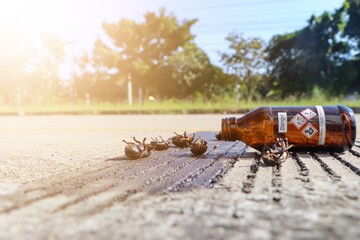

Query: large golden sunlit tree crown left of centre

[93,9,196,99]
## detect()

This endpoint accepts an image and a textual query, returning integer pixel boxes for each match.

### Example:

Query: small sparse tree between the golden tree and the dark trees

[221,33,266,101]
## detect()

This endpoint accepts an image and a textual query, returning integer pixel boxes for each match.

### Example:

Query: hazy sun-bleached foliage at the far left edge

[0,29,64,104]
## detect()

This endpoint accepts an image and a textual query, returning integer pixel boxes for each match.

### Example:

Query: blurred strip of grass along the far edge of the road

[0,99,360,115]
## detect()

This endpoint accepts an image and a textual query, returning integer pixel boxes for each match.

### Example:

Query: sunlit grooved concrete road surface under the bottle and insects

[0,115,360,239]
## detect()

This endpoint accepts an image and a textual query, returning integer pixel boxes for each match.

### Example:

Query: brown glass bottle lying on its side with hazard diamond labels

[221,105,356,151]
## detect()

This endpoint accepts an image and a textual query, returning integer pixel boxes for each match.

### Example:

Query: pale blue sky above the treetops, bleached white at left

[0,0,343,71]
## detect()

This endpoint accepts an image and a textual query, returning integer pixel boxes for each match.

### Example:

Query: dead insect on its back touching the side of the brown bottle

[261,138,293,167]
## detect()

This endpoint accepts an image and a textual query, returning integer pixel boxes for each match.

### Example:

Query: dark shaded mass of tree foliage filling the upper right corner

[267,0,360,98]
